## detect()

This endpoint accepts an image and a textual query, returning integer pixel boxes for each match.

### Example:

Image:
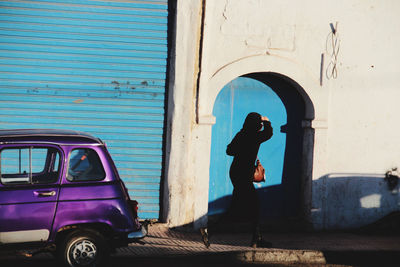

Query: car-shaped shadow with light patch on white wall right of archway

[311,173,400,230]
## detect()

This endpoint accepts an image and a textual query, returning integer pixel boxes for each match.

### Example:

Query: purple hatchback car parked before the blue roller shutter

[0,130,147,266]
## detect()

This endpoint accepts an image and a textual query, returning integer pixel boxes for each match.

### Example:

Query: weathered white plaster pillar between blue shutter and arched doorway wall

[161,0,201,226]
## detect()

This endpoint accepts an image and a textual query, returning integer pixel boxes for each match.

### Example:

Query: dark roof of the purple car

[0,129,103,145]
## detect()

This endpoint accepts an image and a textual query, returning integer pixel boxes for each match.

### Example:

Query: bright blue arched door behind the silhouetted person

[208,77,287,218]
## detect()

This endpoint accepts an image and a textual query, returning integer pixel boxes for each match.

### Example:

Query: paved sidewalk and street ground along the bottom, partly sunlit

[0,224,400,266]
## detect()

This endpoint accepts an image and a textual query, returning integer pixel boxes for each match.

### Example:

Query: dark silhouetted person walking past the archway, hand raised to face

[200,112,272,248]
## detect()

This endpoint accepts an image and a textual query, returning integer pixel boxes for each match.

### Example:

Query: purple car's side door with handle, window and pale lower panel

[0,144,63,244]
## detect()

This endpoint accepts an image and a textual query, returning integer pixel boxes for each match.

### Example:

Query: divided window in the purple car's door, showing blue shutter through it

[0,146,61,185]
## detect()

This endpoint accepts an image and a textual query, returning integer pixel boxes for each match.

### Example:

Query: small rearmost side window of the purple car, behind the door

[67,148,106,182]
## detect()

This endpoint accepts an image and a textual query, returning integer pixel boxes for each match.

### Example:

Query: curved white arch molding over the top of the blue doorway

[198,55,319,124]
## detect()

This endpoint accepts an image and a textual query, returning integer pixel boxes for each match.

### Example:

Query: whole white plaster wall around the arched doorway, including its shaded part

[166,0,400,228]
